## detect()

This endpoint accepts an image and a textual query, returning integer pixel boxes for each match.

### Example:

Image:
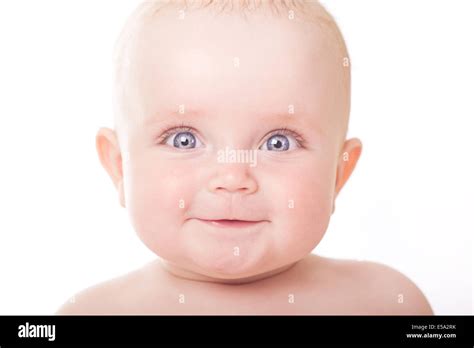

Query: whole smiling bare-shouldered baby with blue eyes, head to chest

[56,0,433,315]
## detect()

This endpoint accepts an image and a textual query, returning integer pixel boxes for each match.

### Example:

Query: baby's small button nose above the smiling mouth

[209,163,258,194]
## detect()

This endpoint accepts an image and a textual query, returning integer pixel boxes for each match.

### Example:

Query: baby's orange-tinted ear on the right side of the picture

[332,138,362,200]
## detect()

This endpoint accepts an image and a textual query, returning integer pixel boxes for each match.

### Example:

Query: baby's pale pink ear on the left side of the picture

[95,127,125,207]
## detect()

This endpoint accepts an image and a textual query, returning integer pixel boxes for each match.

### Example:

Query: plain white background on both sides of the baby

[0,0,474,314]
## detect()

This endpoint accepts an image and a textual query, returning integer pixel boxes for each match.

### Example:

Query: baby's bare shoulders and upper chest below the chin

[56,255,433,315]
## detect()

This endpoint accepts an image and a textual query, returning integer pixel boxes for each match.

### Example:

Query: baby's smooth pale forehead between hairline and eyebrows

[122,9,340,129]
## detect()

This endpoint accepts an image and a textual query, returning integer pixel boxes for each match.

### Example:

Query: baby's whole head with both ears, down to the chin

[97,0,361,282]
